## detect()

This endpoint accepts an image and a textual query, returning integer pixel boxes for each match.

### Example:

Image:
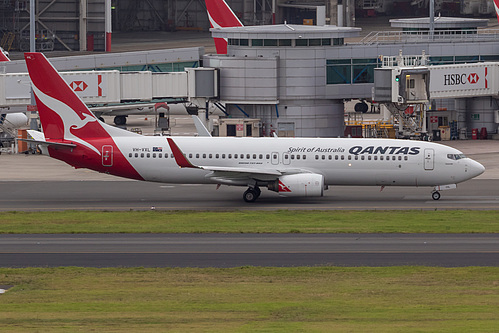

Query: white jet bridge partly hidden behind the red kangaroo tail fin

[0,67,218,107]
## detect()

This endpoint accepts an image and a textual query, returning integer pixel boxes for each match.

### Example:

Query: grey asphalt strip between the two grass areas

[0,234,499,267]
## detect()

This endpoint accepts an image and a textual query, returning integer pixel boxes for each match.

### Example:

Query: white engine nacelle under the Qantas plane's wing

[268,173,325,197]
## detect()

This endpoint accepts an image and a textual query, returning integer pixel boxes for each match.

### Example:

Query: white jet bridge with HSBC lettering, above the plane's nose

[372,54,499,139]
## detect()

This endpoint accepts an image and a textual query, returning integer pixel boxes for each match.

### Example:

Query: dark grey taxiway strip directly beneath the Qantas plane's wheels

[0,179,499,211]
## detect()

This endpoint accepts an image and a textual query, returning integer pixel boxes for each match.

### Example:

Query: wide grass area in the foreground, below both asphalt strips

[0,267,499,332]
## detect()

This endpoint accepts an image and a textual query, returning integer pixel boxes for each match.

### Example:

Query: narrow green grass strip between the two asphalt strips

[0,210,499,234]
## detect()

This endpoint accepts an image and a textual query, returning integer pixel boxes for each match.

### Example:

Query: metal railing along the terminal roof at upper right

[360,29,499,45]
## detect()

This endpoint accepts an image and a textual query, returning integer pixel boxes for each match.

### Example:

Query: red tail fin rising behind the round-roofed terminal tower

[205,0,244,54]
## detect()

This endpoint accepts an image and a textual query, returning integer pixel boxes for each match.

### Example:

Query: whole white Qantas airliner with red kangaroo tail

[25,53,485,202]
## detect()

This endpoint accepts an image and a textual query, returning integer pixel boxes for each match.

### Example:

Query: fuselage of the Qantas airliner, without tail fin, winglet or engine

[51,136,483,186]
